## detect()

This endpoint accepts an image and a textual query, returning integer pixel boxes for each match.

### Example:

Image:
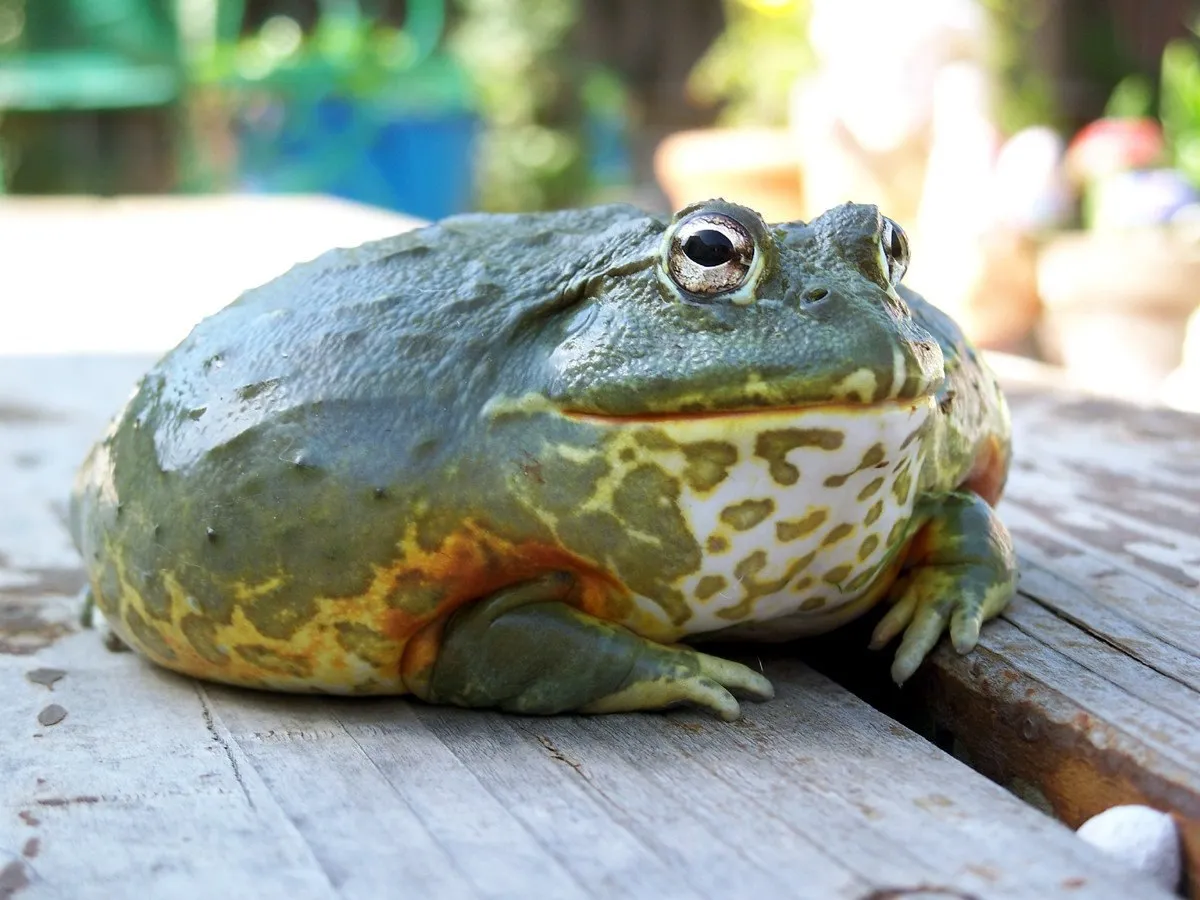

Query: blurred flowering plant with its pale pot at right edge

[1038,30,1200,398]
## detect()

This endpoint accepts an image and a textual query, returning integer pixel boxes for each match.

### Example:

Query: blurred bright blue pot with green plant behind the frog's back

[191,0,476,218]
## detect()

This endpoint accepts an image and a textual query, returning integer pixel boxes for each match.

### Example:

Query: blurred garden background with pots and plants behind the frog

[7,0,1200,410]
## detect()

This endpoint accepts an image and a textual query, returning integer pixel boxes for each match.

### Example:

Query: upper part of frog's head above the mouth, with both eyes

[542,200,943,416]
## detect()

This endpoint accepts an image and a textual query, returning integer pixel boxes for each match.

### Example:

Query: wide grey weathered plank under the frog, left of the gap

[0,359,1165,898]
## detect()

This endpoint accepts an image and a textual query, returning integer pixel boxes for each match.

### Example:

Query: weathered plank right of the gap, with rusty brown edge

[912,366,1200,896]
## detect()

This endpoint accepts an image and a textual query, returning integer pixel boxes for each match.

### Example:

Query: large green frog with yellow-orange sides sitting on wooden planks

[68,199,1016,721]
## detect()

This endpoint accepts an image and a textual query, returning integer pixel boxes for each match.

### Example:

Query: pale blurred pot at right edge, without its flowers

[1038,228,1200,398]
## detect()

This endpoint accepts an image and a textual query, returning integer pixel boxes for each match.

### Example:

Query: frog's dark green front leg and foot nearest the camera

[404,574,775,720]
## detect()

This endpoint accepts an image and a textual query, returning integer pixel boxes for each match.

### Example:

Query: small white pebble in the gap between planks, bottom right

[1075,806,1183,890]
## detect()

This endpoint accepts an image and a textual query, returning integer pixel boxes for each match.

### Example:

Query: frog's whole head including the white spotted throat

[475,200,946,640]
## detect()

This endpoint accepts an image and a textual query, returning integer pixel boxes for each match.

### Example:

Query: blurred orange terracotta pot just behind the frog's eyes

[654,128,803,222]
